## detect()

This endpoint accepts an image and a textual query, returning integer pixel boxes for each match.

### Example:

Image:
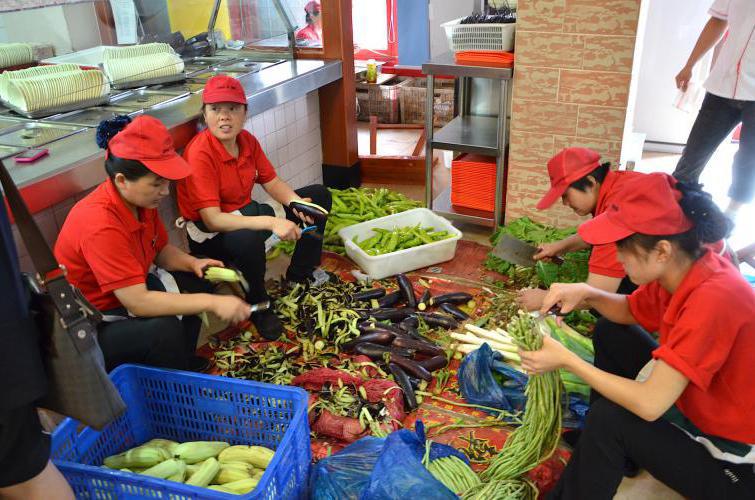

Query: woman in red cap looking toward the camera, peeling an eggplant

[178,75,331,339]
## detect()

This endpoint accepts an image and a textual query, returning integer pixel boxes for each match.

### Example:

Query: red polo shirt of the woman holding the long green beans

[629,251,755,444]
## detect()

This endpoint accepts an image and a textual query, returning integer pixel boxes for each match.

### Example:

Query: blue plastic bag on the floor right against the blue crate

[309,436,385,500]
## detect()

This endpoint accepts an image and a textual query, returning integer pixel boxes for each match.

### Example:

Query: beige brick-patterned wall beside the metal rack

[506,0,640,225]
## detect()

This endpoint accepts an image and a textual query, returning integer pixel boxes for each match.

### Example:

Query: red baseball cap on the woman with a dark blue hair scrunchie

[107,115,191,181]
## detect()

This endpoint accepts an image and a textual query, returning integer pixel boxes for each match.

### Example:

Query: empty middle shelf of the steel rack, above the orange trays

[432,115,500,156]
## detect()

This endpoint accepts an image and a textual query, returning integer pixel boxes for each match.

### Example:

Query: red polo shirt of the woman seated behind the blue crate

[55,180,168,311]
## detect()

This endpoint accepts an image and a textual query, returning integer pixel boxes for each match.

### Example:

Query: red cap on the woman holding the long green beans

[578,173,694,245]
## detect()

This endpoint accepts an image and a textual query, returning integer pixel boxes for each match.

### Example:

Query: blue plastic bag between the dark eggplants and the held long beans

[459,344,527,411]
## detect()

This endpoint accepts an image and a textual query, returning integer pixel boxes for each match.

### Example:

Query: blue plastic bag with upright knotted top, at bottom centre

[361,421,460,500]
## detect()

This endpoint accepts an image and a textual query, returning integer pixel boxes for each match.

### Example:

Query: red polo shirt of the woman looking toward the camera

[177,130,276,221]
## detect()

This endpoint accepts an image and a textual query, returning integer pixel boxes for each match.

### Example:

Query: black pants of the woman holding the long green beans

[548,319,755,500]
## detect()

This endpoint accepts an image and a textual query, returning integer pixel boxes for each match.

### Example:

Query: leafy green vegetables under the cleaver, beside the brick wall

[485,217,590,288]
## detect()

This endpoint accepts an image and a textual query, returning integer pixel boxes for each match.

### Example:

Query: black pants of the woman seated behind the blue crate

[97,272,212,371]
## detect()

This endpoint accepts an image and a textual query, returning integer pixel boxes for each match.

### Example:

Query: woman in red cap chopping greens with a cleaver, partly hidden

[518,148,645,311]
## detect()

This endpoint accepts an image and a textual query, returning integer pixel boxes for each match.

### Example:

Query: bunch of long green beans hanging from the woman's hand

[481,311,561,481]
